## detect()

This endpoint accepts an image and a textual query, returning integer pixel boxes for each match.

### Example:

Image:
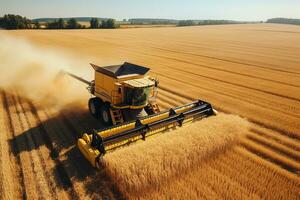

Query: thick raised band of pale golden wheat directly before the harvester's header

[104,114,248,198]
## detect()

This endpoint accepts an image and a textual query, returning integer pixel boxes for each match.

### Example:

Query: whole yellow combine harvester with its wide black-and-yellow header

[65,62,216,168]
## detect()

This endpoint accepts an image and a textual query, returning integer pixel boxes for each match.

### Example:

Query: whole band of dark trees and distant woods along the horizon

[0,14,300,29]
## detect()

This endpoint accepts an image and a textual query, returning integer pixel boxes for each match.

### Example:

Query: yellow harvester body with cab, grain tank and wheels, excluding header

[89,62,159,126]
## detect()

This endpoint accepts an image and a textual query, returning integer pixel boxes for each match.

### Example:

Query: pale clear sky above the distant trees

[0,0,300,21]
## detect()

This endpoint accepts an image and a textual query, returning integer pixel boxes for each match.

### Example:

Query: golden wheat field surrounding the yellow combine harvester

[0,24,300,199]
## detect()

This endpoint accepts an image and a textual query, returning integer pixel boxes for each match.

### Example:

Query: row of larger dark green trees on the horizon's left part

[0,14,119,29]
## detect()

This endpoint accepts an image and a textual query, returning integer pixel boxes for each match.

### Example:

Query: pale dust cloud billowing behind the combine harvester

[0,33,93,107]
